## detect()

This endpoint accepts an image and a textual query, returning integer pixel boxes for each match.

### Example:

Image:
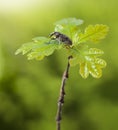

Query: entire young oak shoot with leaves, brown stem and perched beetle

[15,18,109,130]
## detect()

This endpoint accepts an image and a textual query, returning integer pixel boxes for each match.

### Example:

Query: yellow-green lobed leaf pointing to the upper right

[79,24,109,43]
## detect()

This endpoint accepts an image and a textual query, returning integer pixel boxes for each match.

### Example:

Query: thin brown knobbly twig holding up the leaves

[56,56,72,130]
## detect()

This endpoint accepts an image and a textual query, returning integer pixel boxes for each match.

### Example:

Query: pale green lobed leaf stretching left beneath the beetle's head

[15,37,63,60]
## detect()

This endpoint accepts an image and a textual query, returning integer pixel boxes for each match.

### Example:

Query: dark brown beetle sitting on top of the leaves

[49,32,72,46]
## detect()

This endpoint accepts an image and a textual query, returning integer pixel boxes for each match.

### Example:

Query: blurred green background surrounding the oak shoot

[0,0,118,130]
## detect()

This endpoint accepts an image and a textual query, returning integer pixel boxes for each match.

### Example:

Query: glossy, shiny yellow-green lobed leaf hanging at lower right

[69,46,106,78]
